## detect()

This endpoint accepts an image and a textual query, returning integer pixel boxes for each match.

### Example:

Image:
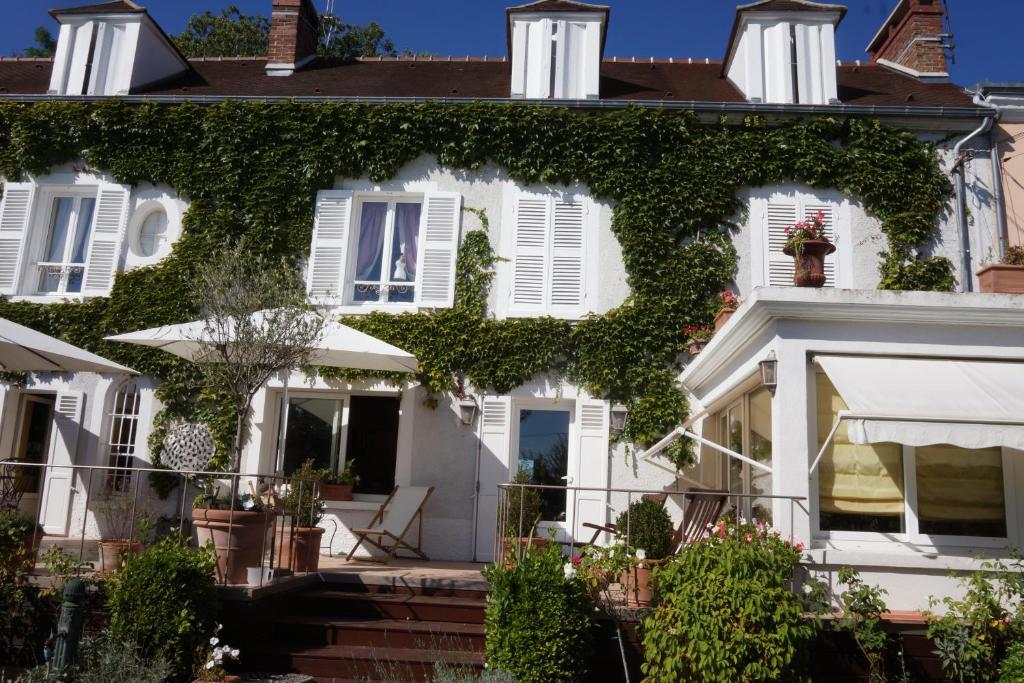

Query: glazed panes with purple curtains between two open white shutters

[349,200,422,303]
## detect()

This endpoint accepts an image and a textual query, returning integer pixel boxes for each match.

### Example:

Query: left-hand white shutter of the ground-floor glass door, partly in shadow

[476,396,512,562]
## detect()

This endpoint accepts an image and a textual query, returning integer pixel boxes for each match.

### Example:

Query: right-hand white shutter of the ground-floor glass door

[568,398,608,542]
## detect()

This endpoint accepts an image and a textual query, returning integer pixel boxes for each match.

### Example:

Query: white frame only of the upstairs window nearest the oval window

[31,184,99,299]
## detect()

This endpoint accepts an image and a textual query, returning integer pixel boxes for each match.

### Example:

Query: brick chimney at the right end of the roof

[867,0,952,78]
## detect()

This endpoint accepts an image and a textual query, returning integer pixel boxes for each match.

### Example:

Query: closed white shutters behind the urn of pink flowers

[750,189,849,287]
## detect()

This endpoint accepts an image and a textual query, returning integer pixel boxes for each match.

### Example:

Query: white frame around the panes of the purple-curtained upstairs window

[342,191,426,311]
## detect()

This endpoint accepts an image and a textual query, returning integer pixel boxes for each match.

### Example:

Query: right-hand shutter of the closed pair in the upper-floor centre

[551,199,587,315]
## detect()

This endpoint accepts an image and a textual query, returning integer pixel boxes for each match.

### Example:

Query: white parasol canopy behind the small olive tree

[106,313,418,373]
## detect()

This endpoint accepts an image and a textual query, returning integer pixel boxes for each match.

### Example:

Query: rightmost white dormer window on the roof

[723,0,846,104]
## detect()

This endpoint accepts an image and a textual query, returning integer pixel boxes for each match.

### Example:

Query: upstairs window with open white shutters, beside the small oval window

[0,182,129,297]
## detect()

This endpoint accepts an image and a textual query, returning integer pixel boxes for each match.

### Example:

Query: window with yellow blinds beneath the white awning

[815,373,1009,545]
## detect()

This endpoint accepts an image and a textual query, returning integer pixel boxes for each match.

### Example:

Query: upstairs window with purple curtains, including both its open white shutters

[307,190,462,308]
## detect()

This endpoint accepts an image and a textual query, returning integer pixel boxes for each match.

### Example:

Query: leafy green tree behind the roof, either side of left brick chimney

[172,5,397,59]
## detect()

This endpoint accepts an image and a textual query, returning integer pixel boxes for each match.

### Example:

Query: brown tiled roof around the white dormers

[0,57,972,106]
